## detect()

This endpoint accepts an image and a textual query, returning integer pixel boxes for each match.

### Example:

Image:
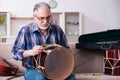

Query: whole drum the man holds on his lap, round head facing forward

[33,44,74,80]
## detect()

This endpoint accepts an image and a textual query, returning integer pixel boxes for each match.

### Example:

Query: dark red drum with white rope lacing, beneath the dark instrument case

[104,49,120,76]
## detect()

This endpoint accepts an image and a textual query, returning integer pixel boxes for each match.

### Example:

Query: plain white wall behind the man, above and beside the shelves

[0,0,120,33]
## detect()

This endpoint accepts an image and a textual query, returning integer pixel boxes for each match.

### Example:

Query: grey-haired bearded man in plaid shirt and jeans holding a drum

[11,2,75,80]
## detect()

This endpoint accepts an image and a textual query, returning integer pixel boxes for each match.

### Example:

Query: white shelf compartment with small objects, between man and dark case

[65,12,81,42]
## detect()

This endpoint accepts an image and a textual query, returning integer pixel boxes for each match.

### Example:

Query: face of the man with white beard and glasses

[34,8,51,29]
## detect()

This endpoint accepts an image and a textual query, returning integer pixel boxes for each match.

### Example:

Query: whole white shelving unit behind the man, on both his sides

[0,12,82,42]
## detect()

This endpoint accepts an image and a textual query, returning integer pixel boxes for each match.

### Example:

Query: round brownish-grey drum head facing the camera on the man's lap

[45,47,74,80]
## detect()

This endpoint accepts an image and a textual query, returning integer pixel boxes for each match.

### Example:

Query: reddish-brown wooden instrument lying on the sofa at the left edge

[0,58,18,76]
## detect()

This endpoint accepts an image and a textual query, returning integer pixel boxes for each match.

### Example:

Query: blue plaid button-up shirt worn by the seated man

[11,23,68,68]
